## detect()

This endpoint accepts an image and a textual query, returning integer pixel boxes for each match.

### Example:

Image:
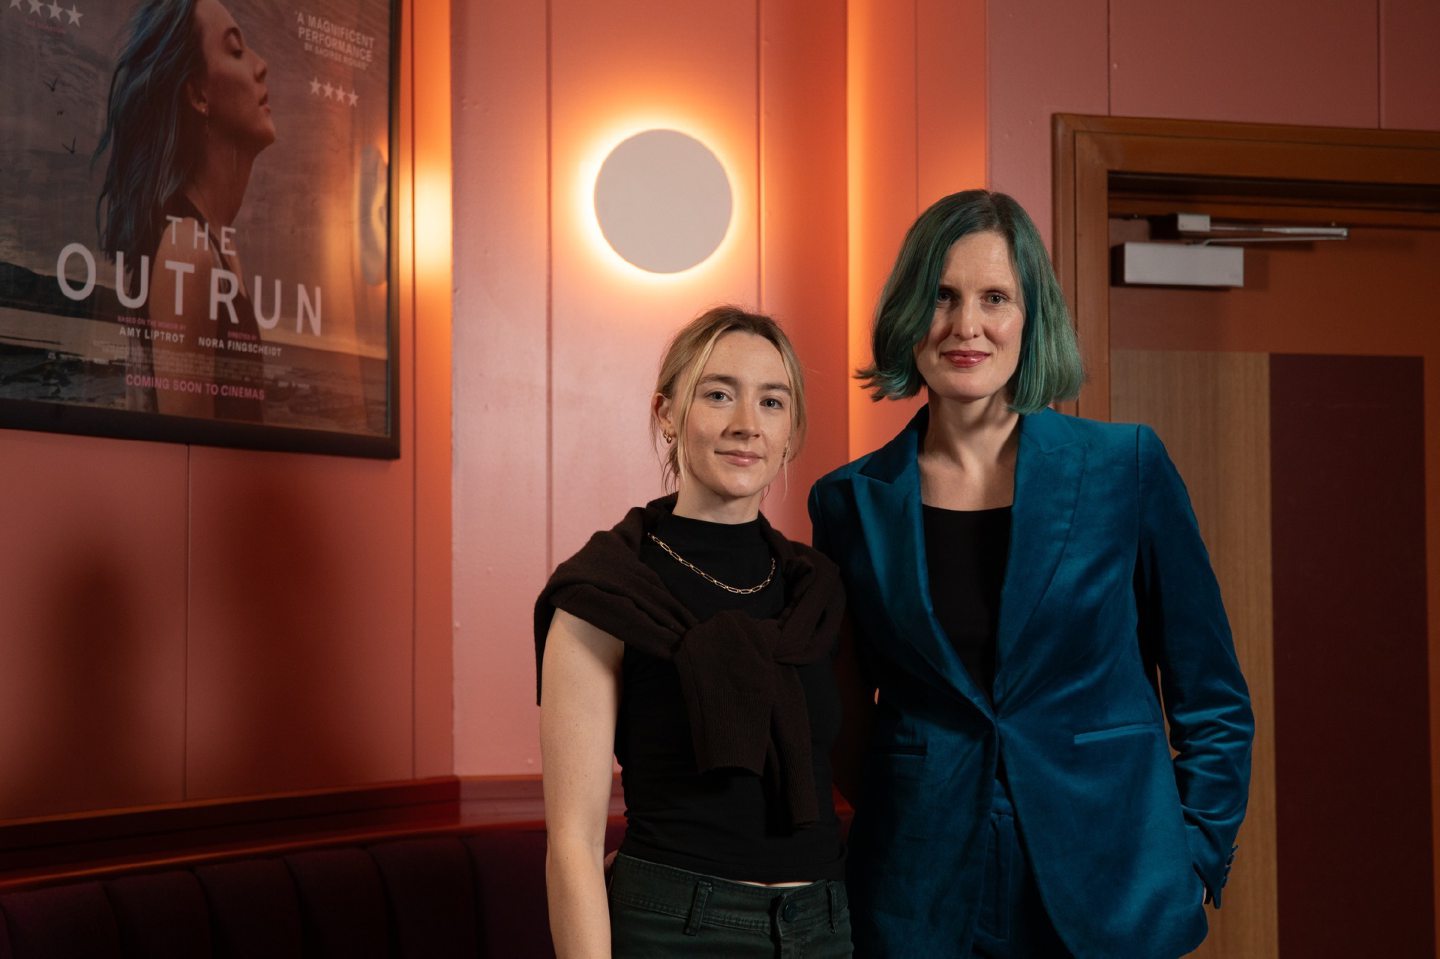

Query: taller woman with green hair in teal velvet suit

[809,190,1254,959]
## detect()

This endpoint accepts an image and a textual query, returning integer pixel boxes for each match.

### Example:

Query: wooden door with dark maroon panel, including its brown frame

[1056,117,1440,959]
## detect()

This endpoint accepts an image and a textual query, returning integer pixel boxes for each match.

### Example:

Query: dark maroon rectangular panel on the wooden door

[1270,356,1434,958]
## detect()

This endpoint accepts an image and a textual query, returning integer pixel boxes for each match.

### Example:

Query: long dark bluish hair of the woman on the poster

[94,0,204,290]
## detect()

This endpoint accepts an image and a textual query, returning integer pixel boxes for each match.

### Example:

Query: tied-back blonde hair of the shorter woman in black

[649,305,806,488]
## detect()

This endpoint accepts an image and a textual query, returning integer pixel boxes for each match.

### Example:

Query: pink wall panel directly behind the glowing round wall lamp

[534,0,759,564]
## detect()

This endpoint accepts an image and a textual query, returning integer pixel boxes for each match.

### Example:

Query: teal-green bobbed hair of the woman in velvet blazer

[855,190,1084,413]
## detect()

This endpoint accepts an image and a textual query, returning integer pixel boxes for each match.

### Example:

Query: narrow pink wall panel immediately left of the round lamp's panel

[454,3,550,773]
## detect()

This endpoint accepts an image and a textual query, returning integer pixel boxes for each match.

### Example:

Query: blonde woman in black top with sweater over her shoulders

[536,307,851,959]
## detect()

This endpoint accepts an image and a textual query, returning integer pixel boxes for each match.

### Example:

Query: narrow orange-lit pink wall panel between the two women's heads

[760,0,850,541]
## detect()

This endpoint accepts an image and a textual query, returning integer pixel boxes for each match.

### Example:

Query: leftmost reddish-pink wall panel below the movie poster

[0,431,186,819]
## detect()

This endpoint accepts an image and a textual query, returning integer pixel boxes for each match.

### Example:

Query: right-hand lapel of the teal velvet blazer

[995,409,1086,701]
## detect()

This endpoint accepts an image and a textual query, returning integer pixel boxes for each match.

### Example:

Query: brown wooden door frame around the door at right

[1053,114,1440,419]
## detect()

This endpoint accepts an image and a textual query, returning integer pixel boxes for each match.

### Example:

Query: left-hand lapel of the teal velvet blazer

[854,408,991,714]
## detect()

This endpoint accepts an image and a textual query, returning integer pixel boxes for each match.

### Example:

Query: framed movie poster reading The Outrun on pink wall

[0,0,397,456]
